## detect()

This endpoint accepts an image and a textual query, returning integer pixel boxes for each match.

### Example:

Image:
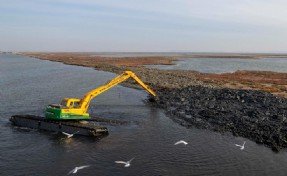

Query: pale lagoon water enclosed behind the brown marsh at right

[147,58,287,73]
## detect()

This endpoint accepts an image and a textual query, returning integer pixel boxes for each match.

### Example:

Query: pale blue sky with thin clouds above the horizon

[0,0,287,53]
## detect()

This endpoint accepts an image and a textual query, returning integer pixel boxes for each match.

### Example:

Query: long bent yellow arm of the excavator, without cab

[80,71,156,112]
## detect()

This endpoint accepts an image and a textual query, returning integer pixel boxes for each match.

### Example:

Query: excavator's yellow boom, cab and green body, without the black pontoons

[45,71,156,120]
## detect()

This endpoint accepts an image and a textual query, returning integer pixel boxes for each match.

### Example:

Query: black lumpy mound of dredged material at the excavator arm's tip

[154,86,287,151]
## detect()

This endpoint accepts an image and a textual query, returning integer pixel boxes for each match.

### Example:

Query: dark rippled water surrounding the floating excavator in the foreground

[0,55,287,176]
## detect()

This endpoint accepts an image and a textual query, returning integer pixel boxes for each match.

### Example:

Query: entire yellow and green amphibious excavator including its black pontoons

[10,71,156,136]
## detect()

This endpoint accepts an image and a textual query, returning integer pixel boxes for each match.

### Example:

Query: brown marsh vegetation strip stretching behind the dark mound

[19,53,287,97]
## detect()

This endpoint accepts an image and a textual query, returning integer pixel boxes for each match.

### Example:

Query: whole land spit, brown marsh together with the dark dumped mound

[19,53,287,151]
